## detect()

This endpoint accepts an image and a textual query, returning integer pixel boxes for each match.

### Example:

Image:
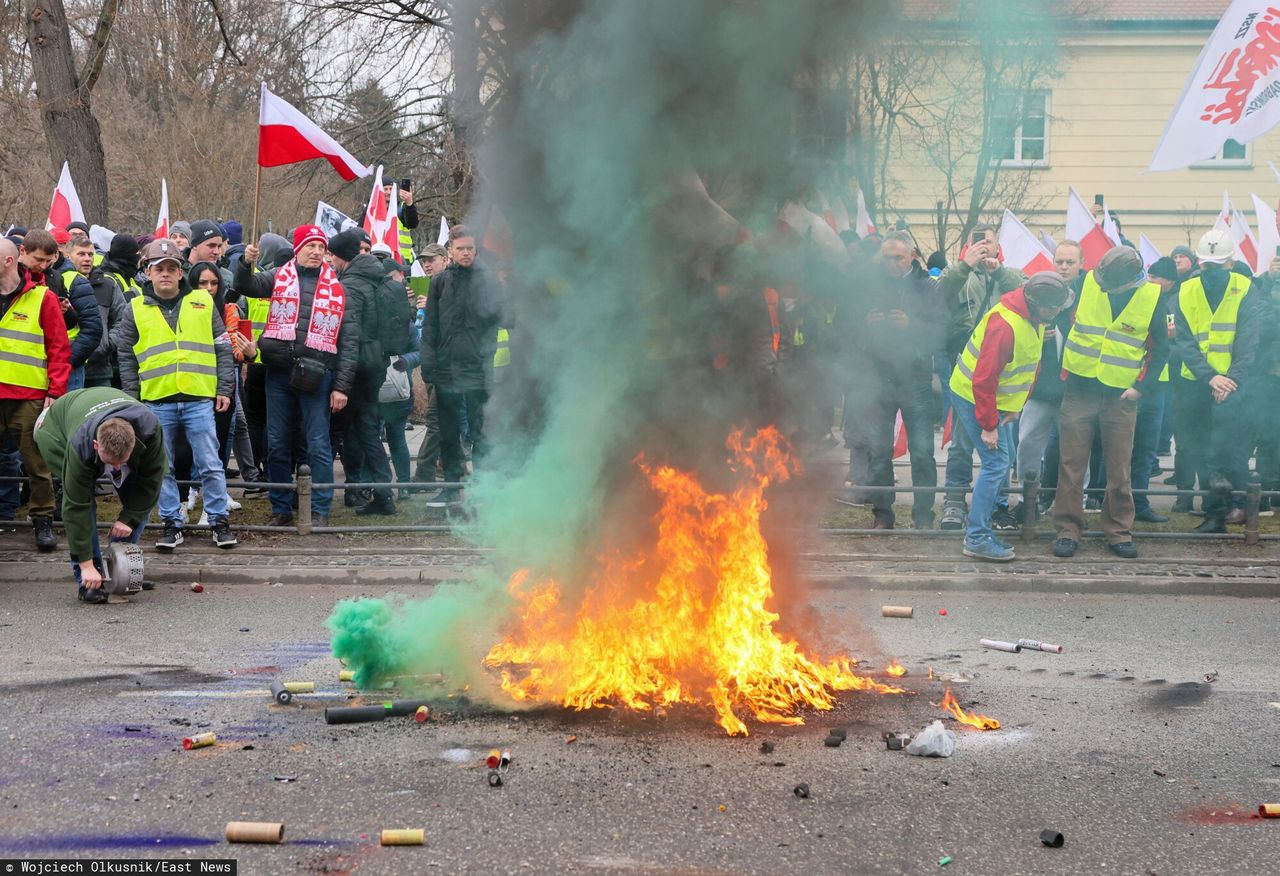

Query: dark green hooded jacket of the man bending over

[36,387,168,562]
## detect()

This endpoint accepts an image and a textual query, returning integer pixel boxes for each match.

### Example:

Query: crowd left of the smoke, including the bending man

[0,178,509,603]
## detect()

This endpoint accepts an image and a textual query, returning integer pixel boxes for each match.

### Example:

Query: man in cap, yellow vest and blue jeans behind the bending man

[115,237,236,553]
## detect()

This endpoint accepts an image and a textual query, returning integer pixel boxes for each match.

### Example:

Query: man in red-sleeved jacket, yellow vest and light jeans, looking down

[950,270,1071,561]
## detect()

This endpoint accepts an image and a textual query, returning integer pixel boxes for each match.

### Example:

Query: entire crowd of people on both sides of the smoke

[0,181,1280,602]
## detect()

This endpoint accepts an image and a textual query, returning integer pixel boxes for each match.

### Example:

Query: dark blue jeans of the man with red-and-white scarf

[266,368,333,517]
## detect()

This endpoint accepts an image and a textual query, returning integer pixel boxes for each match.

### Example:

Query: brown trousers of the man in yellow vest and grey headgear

[1053,383,1138,544]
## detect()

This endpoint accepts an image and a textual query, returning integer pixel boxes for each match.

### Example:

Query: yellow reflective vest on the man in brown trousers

[1062,270,1160,389]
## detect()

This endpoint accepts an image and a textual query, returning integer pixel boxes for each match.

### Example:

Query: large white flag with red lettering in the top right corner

[1149,0,1280,170]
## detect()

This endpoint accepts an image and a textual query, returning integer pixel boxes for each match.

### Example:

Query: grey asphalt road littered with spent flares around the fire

[0,578,1280,876]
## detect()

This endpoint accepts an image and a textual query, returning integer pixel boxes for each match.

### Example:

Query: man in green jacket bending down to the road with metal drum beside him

[36,387,165,604]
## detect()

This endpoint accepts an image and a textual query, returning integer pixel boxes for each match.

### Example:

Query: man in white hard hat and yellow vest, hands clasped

[1174,229,1271,533]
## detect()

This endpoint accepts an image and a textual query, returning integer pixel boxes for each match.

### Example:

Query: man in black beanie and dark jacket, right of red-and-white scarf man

[329,228,394,515]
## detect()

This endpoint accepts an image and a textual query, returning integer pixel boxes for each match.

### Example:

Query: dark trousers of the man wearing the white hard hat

[1178,380,1257,520]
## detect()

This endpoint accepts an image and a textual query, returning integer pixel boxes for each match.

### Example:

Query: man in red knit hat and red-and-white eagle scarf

[234,225,360,526]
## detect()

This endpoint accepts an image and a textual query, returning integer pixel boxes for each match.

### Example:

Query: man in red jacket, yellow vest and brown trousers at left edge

[0,239,72,551]
